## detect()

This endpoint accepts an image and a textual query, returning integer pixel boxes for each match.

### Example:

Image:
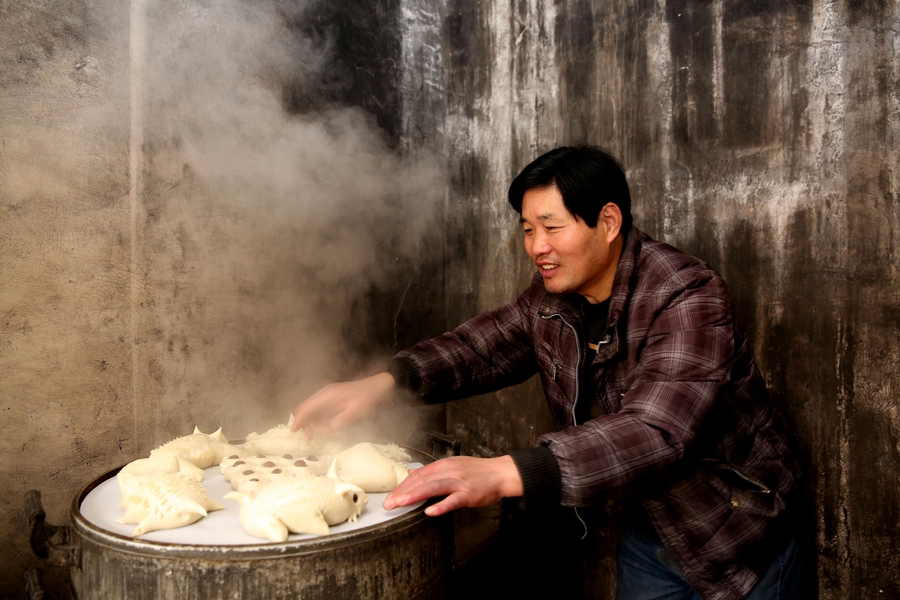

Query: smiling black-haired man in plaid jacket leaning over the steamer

[294,147,799,600]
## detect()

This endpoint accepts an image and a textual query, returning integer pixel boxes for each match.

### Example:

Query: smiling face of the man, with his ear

[522,186,621,303]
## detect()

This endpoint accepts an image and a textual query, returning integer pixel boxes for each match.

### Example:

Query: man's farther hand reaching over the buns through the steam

[291,371,397,438]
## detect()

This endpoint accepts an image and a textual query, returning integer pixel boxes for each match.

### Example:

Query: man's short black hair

[509,146,631,236]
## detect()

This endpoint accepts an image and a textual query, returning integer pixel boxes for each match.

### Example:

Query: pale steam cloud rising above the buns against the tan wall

[132,0,443,435]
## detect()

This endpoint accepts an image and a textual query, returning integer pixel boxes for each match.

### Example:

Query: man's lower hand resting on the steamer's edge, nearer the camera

[383,455,524,517]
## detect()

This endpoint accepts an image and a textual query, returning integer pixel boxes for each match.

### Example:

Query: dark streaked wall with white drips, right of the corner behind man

[403,0,900,599]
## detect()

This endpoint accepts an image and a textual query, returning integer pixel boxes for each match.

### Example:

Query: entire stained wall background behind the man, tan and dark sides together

[0,0,900,599]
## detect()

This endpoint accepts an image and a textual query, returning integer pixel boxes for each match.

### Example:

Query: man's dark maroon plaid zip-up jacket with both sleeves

[398,229,799,600]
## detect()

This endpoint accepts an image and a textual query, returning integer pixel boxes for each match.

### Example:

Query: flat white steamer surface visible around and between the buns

[79,463,424,546]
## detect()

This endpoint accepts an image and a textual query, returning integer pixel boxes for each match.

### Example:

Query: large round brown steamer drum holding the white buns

[26,448,454,600]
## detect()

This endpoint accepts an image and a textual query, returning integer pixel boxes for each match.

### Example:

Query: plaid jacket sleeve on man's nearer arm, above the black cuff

[539,265,734,506]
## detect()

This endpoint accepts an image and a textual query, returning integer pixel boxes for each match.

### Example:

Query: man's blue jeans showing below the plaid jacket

[616,529,802,600]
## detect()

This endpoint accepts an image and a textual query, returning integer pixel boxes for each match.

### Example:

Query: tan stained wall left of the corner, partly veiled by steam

[0,0,445,596]
